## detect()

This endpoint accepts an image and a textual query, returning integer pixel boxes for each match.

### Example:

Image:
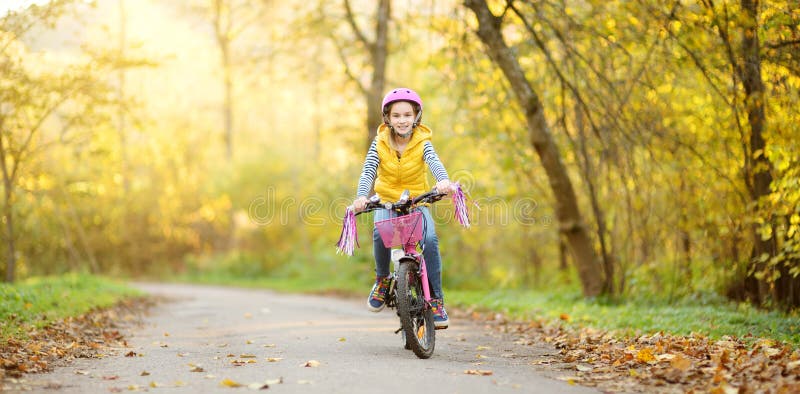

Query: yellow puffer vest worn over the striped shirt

[375,124,433,202]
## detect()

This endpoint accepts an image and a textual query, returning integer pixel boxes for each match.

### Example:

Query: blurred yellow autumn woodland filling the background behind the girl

[0,0,800,307]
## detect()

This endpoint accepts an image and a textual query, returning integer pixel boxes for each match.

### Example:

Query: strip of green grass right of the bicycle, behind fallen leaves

[447,290,800,346]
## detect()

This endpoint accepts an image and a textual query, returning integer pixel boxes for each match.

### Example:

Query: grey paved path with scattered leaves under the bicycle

[10,284,596,394]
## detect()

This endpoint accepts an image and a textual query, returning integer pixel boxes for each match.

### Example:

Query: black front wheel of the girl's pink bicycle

[395,259,436,359]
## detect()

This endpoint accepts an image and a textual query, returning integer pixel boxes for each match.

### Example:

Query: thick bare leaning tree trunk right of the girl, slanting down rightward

[465,0,603,297]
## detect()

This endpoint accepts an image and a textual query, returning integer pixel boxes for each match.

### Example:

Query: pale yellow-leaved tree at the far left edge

[0,1,109,282]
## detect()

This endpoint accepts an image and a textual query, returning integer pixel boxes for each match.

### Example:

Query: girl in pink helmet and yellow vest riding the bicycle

[353,88,453,329]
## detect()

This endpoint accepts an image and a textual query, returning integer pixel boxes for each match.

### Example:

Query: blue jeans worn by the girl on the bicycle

[372,206,444,298]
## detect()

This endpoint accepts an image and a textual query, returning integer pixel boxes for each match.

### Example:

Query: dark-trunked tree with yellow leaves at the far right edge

[665,0,800,306]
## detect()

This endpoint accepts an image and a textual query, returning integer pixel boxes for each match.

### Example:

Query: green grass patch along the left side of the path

[0,274,140,343]
